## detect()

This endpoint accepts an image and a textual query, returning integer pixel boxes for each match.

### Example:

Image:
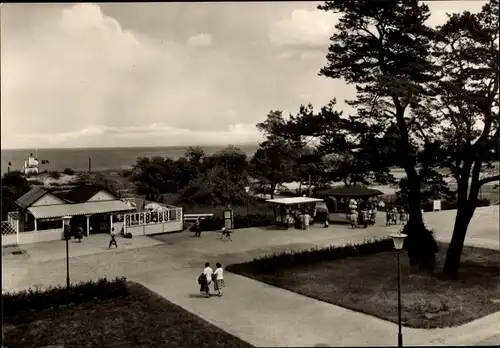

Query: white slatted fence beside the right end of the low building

[123,208,183,235]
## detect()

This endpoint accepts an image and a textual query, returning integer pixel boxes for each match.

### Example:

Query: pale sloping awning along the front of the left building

[28,200,136,219]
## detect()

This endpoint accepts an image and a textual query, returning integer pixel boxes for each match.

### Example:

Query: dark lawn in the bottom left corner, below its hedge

[2,283,252,348]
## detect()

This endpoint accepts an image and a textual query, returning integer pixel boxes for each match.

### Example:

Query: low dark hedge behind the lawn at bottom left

[2,278,129,318]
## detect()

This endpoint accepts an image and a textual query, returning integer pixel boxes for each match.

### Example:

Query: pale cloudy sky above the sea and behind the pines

[0,0,485,149]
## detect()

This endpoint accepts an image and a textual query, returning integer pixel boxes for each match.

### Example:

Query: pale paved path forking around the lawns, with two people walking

[3,210,500,346]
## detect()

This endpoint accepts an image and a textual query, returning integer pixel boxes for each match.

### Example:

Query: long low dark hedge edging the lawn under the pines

[227,238,394,274]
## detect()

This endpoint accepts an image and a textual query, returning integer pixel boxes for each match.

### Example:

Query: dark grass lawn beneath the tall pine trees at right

[229,243,500,328]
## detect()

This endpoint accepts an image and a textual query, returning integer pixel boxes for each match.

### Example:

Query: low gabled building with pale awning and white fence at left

[0,185,183,246]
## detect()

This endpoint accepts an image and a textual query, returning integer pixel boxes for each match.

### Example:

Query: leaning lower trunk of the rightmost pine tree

[443,201,475,279]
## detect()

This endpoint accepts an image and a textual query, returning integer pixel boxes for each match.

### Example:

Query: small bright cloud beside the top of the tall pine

[269,10,336,47]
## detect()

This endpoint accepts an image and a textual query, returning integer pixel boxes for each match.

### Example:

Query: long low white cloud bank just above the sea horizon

[2,123,262,148]
